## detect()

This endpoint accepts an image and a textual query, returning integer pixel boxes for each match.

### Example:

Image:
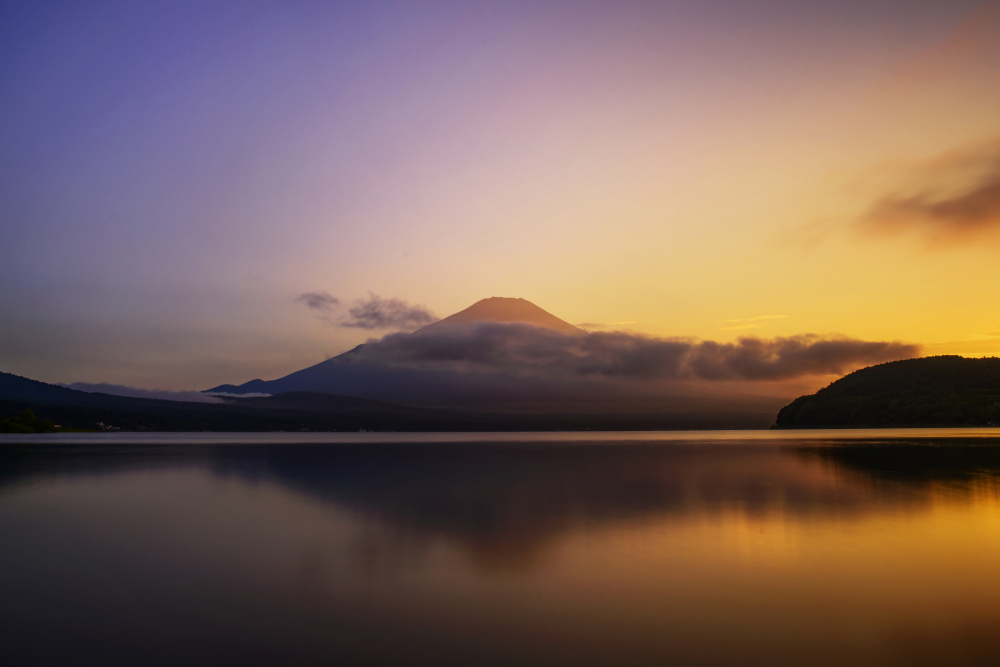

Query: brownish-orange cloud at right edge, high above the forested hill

[860,144,1000,240]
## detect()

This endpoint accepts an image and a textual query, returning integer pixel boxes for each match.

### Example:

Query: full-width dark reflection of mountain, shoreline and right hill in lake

[0,443,1000,567]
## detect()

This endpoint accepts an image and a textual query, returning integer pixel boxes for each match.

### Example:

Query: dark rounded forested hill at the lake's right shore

[774,356,1000,428]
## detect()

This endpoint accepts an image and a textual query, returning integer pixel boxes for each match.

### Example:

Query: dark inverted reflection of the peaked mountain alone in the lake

[254,444,857,567]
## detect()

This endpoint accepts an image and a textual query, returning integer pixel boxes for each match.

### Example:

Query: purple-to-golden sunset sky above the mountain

[0,0,1000,391]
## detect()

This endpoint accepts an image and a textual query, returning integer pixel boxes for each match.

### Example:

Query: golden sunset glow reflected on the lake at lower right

[516,483,1000,664]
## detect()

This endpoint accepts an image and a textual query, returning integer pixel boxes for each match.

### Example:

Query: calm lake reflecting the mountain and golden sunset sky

[0,430,1000,665]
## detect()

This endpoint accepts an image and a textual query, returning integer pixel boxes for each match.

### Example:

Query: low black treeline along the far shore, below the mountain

[0,373,771,432]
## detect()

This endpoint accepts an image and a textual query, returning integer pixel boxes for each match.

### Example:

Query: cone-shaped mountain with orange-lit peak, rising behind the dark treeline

[207,297,787,428]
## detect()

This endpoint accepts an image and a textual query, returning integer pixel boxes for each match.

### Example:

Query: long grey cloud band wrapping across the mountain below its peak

[354,323,919,381]
